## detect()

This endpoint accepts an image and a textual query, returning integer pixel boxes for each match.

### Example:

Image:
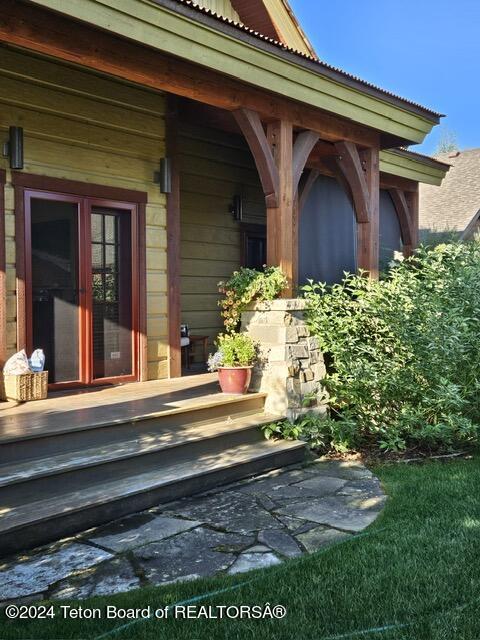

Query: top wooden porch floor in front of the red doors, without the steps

[0,373,228,442]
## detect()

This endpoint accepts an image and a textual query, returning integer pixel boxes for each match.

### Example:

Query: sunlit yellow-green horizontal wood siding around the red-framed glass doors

[0,48,168,379]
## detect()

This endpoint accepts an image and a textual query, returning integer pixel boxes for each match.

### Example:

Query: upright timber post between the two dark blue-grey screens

[357,148,380,278]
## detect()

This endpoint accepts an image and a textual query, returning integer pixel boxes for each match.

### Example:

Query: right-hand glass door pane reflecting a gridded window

[91,207,133,380]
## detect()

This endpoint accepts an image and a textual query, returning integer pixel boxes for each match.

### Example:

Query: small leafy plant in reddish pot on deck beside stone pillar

[208,333,257,394]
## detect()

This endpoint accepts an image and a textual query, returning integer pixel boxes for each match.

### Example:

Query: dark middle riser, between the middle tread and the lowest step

[0,426,263,507]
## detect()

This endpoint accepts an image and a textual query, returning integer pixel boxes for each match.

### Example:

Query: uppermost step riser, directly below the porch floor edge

[0,396,264,464]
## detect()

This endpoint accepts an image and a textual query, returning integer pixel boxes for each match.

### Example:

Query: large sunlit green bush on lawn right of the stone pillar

[303,242,480,451]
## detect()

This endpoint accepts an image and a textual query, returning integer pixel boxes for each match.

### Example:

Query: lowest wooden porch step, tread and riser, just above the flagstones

[0,440,305,555]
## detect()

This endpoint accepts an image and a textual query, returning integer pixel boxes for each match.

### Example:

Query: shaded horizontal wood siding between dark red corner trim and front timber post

[179,124,265,356]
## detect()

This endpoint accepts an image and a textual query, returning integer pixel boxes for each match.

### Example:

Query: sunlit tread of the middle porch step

[0,412,280,488]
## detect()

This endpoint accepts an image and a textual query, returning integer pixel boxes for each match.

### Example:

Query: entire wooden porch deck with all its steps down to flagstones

[0,374,305,555]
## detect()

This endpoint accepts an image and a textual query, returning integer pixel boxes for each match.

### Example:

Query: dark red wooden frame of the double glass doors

[12,173,147,388]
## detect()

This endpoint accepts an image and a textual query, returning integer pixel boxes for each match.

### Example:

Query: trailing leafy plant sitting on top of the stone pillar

[218,267,287,331]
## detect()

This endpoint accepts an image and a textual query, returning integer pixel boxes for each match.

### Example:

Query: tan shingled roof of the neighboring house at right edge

[420,149,480,233]
